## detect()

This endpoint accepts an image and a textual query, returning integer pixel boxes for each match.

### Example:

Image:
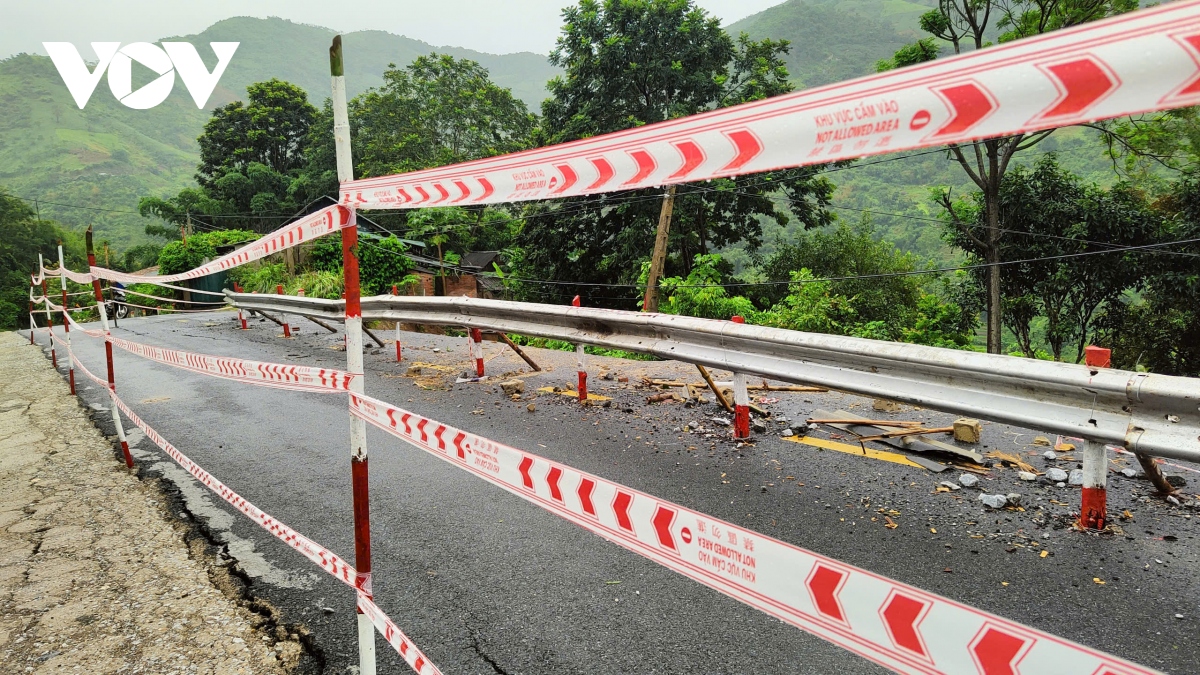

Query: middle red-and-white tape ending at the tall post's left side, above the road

[108,336,356,394]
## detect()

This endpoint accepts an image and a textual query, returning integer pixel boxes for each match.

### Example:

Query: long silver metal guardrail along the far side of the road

[227,292,1200,461]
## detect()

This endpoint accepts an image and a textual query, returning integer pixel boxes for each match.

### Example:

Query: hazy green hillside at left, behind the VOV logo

[0,18,557,249]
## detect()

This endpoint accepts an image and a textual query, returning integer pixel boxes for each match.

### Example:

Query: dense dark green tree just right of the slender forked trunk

[947,155,1163,360]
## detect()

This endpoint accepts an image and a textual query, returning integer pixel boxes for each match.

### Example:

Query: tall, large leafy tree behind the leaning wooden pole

[518,0,833,306]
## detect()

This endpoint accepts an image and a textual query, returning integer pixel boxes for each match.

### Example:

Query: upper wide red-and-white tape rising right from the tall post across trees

[340,0,1200,209]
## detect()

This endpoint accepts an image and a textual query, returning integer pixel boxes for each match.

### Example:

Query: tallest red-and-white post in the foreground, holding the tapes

[329,35,376,675]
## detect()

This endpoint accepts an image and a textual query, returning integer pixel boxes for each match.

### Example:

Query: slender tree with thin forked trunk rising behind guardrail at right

[881,0,1138,353]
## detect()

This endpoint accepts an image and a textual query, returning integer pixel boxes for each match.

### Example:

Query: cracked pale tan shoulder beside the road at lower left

[0,333,300,674]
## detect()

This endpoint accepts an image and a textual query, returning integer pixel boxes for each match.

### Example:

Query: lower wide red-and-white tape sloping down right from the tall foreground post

[349,394,1153,675]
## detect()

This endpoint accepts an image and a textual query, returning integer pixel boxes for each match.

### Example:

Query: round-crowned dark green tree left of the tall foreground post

[138,79,317,235]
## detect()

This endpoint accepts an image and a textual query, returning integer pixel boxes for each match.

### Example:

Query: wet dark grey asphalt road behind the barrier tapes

[23,312,1200,674]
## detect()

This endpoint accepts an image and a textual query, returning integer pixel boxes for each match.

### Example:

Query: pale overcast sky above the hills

[0,0,784,58]
